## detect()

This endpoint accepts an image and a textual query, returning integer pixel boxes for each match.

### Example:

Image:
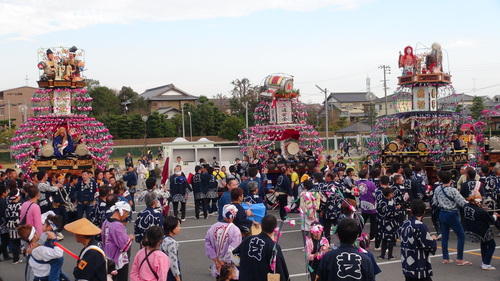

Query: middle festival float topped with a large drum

[238,74,323,173]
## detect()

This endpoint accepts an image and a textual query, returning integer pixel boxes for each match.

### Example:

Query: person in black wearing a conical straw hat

[64,218,107,281]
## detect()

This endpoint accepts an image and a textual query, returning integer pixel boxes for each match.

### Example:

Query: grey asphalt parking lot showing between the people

[0,198,500,281]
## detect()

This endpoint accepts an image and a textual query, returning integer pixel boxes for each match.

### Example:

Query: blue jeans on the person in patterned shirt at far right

[439,210,465,260]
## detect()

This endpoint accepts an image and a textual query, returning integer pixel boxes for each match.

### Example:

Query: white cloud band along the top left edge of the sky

[0,0,370,40]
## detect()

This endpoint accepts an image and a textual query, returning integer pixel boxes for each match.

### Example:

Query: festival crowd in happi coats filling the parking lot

[0,151,500,281]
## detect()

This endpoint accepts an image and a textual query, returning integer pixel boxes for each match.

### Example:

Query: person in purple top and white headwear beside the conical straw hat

[101,201,135,281]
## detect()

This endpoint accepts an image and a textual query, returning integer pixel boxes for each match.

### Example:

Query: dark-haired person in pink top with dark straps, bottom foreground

[130,226,170,281]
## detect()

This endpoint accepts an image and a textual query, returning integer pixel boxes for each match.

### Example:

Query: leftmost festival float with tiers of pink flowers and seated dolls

[11,46,113,174]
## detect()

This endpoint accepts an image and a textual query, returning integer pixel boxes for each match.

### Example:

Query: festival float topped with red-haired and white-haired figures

[368,43,485,179]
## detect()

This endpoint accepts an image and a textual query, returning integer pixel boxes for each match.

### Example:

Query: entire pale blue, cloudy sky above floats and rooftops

[0,0,500,102]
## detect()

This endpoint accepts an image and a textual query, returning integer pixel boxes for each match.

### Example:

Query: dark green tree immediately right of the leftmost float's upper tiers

[89,86,121,116]
